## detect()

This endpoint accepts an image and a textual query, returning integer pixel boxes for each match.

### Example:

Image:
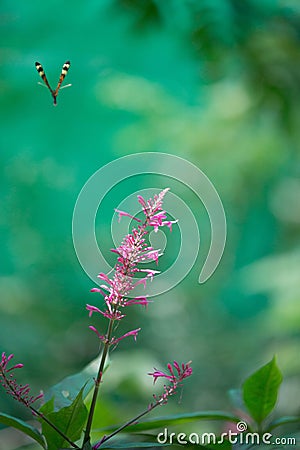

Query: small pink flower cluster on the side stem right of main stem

[148,361,193,409]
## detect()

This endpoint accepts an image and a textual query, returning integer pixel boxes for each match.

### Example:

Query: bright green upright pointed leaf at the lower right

[243,356,282,425]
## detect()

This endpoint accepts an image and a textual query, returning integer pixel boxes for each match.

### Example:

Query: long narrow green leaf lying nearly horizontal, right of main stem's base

[94,411,241,433]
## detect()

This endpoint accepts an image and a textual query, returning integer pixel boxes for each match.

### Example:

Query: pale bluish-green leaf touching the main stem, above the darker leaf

[44,355,108,411]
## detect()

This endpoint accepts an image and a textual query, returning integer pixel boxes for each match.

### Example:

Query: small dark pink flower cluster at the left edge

[0,352,43,407]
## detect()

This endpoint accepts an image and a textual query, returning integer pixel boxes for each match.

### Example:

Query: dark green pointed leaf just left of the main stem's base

[41,388,87,450]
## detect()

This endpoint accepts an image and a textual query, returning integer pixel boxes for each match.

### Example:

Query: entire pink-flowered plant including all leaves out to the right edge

[0,189,300,450]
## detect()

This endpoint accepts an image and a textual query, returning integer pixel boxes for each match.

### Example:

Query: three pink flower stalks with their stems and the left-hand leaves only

[0,189,192,450]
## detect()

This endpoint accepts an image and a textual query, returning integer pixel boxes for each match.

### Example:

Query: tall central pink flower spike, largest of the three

[86,189,177,345]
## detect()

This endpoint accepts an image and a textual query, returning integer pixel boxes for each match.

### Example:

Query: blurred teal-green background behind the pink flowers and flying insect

[0,0,300,450]
